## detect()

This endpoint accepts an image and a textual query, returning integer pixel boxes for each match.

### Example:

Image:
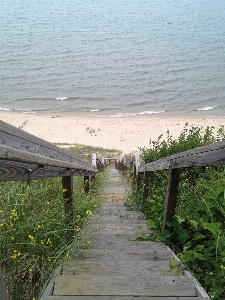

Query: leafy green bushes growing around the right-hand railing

[127,124,225,300]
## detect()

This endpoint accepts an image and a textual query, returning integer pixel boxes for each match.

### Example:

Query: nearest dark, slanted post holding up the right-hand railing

[162,160,181,232]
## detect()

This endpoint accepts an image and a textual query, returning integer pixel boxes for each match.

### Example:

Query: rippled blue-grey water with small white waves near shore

[0,0,225,118]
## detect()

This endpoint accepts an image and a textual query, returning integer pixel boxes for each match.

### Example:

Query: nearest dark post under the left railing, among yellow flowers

[62,169,74,236]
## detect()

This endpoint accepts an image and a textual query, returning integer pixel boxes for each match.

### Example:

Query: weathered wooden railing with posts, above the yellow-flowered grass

[0,121,106,300]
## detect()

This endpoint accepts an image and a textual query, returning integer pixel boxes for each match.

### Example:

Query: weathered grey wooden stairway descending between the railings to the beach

[42,168,209,300]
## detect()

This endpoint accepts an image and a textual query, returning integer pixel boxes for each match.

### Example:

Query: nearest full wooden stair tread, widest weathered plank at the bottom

[54,275,197,296]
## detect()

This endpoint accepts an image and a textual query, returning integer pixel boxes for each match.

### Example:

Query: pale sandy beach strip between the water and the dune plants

[0,112,225,154]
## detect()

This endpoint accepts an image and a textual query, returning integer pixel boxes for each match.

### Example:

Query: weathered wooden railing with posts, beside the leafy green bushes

[116,142,225,231]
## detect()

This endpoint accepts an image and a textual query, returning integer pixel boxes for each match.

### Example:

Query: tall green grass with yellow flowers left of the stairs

[0,146,107,300]
